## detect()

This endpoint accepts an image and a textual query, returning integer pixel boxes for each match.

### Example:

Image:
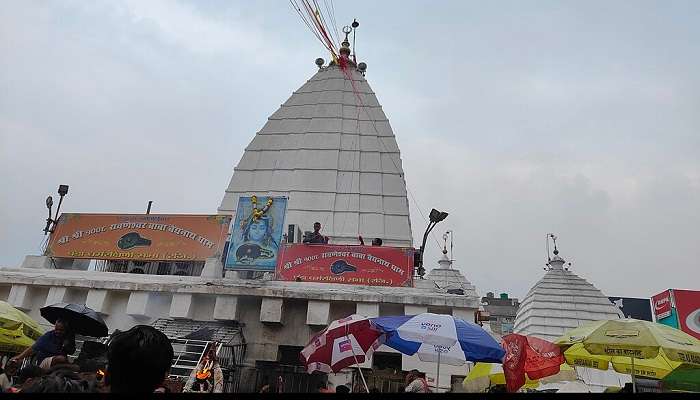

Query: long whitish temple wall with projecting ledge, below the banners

[0,262,478,389]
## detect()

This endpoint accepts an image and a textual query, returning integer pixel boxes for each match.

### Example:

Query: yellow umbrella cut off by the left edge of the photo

[0,301,44,353]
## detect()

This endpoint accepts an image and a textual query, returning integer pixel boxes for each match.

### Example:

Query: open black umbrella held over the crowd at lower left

[40,303,108,337]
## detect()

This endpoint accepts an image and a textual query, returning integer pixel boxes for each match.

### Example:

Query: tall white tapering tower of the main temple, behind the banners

[218,63,412,246]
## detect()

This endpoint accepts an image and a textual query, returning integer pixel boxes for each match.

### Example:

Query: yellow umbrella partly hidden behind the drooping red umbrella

[462,363,576,393]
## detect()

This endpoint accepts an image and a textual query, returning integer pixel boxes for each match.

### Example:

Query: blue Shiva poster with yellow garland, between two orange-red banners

[226,195,287,272]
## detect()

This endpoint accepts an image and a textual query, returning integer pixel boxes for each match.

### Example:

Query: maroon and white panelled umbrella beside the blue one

[300,315,381,373]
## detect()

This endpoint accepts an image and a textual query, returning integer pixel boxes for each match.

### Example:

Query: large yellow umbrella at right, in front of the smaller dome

[555,318,700,392]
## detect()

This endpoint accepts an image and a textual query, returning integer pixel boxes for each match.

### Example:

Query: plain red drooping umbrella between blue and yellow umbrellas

[501,333,565,392]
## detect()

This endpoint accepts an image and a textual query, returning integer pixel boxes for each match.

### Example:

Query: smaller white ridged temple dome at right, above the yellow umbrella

[513,252,620,341]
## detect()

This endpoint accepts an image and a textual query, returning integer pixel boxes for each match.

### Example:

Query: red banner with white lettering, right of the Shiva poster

[277,244,413,286]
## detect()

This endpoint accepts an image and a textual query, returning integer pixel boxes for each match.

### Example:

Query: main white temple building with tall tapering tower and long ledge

[0,36,480,392]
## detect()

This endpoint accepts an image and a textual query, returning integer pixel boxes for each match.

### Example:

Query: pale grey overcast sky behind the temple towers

[0,0,700,298]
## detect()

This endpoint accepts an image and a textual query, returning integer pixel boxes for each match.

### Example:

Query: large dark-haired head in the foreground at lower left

[106,325,173,393]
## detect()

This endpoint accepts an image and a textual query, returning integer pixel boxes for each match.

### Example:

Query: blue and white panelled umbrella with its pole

[372,313,505,387]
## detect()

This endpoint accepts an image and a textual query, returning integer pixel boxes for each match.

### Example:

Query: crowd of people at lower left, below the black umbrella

[0,320,174,393]
